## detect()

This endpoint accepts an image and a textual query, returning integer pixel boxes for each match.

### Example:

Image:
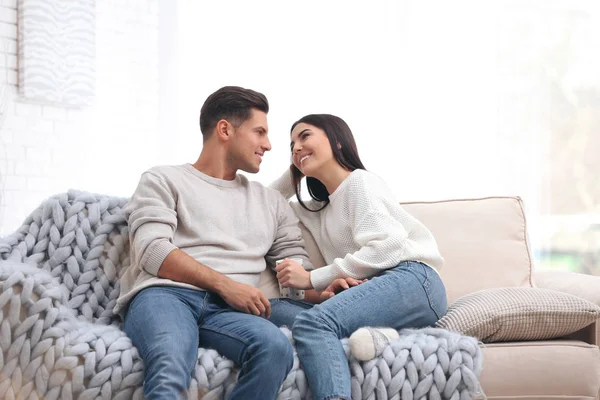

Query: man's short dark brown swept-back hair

[200,86,269,140]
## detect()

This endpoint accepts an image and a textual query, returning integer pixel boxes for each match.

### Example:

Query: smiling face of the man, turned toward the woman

[229,110,271,173]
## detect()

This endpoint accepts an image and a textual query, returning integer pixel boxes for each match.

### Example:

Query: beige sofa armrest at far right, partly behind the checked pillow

[534,270,600,345]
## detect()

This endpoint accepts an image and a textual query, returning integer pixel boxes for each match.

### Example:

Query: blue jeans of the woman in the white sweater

[271,261,446,400]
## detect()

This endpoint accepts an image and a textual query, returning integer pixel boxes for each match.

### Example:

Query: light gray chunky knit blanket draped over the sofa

[0,191,482,400]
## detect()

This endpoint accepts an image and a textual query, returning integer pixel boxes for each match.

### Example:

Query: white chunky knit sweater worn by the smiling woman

[270,169,444,290]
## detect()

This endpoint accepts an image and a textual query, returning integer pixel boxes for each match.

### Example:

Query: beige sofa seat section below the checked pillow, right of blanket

[480,340,600,400]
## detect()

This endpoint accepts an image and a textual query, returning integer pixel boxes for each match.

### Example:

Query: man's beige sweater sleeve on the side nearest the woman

[265,194,313,270]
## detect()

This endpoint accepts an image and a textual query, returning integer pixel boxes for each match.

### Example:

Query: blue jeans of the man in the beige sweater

[124,286,293,400]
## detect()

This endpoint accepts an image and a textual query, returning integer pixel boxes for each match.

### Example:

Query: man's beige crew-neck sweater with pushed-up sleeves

[115,164,312,312]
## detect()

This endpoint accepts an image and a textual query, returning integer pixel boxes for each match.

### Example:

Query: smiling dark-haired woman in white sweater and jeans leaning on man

[271,114,446,400]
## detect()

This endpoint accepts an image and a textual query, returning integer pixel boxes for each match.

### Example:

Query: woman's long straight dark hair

[290,114,366,212]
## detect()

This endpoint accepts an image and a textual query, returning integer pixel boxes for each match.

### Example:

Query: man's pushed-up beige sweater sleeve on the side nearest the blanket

[125,172,177,276]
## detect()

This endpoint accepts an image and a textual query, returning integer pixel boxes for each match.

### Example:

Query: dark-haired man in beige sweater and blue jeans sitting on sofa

[115,86,311,400]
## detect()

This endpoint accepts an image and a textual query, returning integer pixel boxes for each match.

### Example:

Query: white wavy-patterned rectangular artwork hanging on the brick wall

[18,0,96,107]
